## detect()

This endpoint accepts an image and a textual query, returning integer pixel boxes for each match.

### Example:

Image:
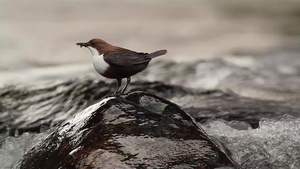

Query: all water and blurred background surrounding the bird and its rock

[0,0,300,169]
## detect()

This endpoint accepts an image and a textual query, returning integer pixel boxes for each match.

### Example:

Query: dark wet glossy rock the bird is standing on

[20,92,236,169]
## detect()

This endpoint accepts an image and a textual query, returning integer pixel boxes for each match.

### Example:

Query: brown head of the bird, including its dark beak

[76,39,117,55]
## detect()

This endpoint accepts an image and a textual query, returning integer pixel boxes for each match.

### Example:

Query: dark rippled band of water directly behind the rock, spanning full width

[0,77,300,135]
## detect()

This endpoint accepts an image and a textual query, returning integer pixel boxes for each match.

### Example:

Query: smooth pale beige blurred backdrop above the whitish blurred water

[0,0,300,71]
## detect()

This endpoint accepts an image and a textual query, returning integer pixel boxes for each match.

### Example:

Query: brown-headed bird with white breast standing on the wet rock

[76,38,167,95]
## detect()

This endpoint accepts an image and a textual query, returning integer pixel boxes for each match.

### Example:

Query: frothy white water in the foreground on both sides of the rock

[0,117,300,169]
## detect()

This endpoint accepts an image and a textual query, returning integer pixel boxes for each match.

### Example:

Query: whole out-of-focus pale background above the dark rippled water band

[0,0,300,100]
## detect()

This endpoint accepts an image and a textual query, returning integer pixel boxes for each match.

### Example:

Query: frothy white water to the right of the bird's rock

[202,117,300,169]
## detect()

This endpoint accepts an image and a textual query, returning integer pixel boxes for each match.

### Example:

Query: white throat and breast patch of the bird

[88,46,109,74]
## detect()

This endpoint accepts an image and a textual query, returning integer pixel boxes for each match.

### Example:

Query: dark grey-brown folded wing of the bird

[103,49,151,66]
